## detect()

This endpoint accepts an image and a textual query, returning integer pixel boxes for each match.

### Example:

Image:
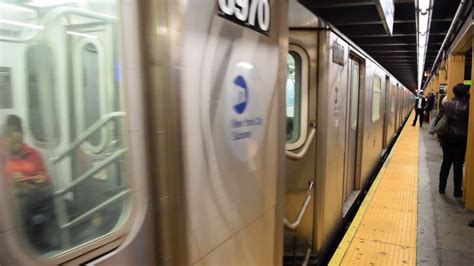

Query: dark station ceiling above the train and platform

[300,0,460,91]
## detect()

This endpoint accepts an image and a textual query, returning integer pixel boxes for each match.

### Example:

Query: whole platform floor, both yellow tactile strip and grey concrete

[330,112,474,266]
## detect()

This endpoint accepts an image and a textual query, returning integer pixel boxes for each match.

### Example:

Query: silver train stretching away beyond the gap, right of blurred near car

[284,2,413,263]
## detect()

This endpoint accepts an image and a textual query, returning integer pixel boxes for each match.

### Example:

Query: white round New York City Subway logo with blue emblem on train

[226,72,264,161]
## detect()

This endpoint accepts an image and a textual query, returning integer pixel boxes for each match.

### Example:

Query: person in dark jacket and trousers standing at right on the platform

[437,83,469,197]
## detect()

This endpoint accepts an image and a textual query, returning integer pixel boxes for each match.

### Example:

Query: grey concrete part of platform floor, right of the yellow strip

[418,124,474,266]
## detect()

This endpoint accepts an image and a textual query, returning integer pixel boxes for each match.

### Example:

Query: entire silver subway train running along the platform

[0,0,414,265]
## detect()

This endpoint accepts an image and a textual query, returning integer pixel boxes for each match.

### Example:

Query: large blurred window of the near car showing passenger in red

[0,0,131,264]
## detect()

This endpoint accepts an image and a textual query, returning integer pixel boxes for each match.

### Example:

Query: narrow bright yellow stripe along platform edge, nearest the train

[328,112,412,266]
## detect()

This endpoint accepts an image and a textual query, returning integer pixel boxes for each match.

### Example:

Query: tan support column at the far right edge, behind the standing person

[464,39,474,211]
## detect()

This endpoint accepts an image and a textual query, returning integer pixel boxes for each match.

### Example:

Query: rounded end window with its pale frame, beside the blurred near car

[286,45,308,150]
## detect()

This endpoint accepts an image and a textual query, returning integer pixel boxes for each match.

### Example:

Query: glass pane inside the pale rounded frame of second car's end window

[286,51,301,143]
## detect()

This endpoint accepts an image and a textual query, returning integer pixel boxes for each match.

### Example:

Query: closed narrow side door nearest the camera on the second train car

[343,58,360,208]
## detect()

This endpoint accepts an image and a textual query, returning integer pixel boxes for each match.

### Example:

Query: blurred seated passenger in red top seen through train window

[1,115,56,251]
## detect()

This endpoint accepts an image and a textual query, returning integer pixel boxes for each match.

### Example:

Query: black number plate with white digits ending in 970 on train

[217,0,271,35]
